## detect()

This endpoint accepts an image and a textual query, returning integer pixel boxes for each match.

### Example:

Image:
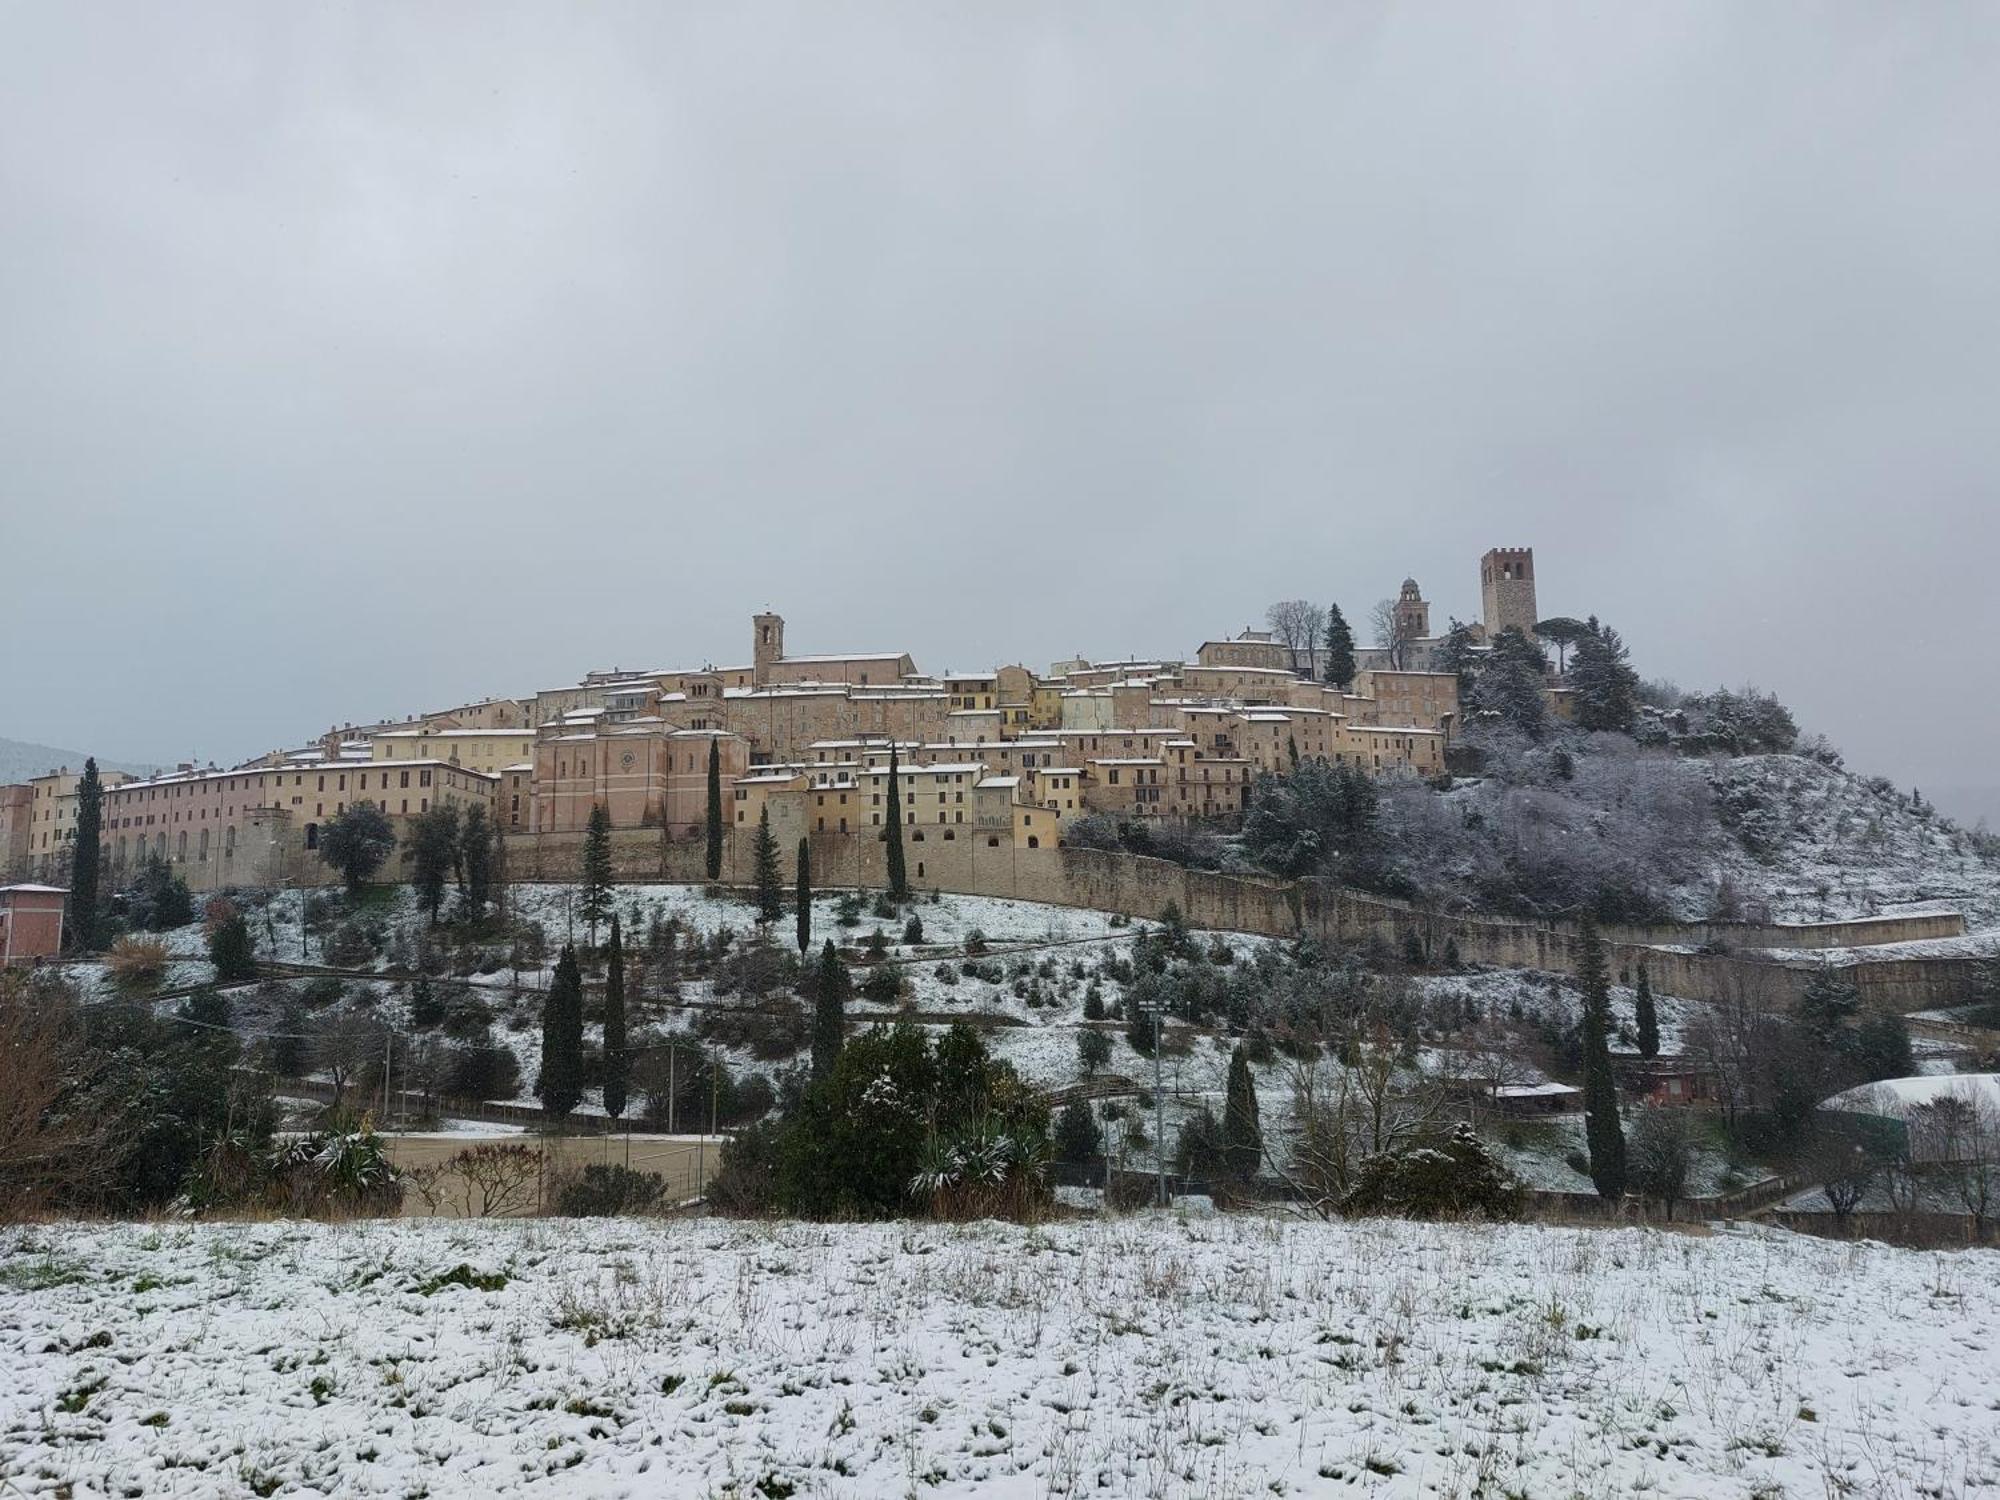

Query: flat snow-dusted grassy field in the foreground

[0,1218,2000,1500]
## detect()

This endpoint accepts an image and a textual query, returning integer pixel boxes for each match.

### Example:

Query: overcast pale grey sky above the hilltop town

[0,0,2000,816]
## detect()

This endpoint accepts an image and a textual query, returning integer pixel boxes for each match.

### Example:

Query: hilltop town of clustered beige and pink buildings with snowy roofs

[0,548,1544,892]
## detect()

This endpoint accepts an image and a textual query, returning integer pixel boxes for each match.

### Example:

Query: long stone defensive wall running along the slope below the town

[506,826,1972,1012]
